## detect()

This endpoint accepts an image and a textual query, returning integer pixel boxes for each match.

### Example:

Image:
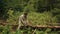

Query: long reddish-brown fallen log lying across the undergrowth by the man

[0,23,60,28]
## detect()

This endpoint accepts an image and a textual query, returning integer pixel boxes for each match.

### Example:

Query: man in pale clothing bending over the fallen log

[18,12,28,29]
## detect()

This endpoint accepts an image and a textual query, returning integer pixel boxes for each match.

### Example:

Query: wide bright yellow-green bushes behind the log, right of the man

[28,12,57,25]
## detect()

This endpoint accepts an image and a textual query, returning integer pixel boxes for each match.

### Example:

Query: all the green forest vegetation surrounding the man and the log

[0,0,60,34]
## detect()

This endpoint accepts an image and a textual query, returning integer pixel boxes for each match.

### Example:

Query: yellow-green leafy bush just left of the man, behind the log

[7,10,22,24]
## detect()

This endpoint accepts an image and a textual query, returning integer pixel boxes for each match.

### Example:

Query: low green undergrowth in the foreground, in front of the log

[1,25,60,34]
